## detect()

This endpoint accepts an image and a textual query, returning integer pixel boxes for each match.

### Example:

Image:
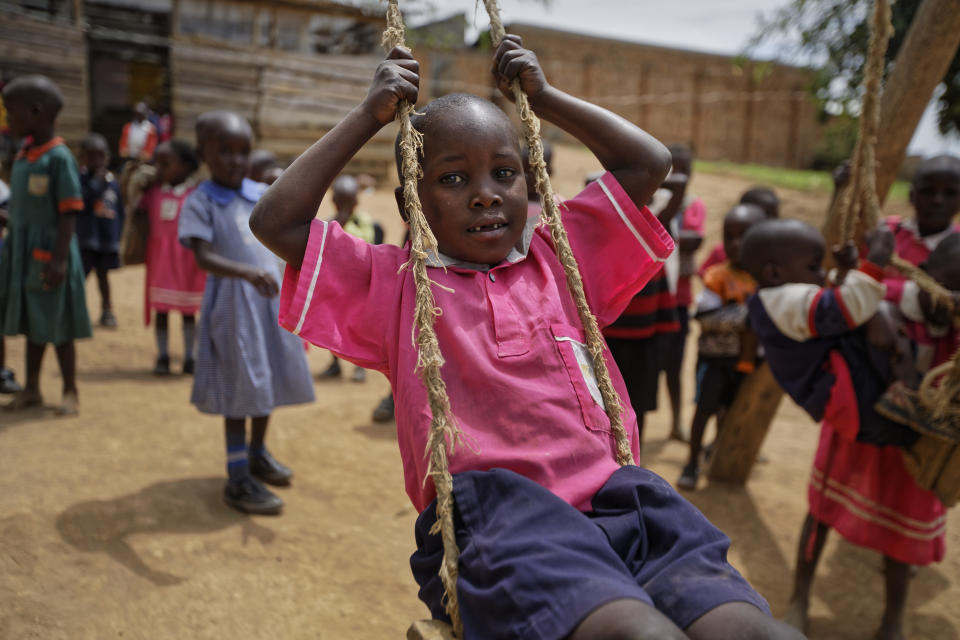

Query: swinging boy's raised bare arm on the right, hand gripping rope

[493,35,671,207]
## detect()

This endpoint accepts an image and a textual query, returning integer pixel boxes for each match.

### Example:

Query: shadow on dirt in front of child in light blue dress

[56,478,274,586]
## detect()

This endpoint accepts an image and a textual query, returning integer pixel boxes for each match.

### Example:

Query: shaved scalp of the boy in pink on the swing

[394,93,520,182]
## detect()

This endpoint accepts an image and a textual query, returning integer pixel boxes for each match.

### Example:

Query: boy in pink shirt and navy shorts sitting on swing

[250,36,800,640]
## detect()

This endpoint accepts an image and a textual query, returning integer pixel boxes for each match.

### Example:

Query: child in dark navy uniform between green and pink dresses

[77,133,123,328]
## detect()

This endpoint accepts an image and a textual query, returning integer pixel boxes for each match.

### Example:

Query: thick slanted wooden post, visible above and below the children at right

[710,0,960,482]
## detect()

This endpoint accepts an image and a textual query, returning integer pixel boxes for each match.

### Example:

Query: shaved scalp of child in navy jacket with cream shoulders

[740,218,824,284]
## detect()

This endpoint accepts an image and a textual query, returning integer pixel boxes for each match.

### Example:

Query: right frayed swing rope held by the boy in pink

[483,0,634,465]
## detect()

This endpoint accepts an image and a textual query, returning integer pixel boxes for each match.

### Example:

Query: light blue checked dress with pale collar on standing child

[179,178,314,418]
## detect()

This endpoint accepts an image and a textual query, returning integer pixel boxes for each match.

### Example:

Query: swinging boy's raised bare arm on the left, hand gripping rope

[250,47,420,268]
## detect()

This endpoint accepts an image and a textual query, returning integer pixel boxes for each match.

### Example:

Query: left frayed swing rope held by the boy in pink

[382,0,463,638]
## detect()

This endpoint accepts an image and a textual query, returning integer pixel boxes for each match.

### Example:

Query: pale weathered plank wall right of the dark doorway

[170,38,396,177]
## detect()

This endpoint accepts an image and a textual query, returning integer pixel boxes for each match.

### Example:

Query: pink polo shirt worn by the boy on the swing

[280,173,673,511]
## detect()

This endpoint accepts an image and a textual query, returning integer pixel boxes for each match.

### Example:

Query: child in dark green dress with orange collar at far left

[0,76,92,415]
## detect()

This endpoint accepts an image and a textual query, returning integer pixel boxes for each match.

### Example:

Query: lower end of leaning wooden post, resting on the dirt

[709,362,783,482]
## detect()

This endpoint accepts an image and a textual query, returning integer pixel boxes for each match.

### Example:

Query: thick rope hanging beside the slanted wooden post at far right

[828,0,960,418]
